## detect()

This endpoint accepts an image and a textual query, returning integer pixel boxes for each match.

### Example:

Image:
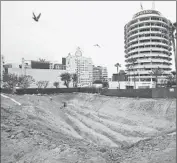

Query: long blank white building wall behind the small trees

[8,68,73,88]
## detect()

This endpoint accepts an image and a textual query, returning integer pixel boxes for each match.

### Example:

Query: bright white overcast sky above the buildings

[1,1,176,77]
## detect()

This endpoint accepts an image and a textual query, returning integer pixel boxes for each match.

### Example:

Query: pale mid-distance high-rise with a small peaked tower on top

[66,48,93,86]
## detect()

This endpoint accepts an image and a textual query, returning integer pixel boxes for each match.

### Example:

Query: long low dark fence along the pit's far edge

[1,88,177,98]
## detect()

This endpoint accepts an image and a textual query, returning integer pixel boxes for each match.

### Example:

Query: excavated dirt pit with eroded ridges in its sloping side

[1,93,176,163]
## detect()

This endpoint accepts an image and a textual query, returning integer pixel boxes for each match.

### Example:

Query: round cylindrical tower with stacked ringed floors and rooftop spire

[124,10,172,85]
